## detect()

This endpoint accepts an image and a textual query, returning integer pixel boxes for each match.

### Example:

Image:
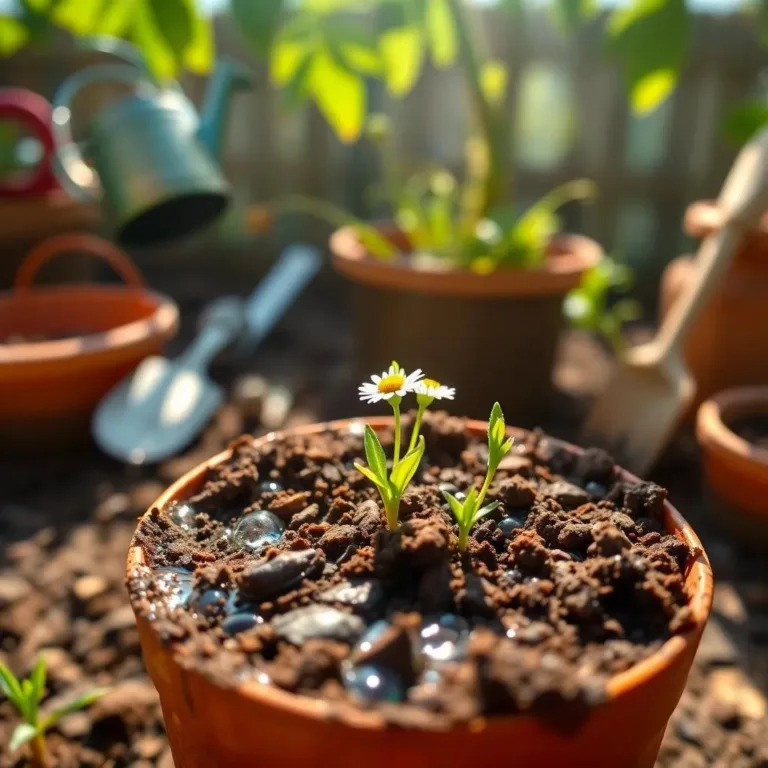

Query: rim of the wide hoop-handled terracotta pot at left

[0,284,179,366]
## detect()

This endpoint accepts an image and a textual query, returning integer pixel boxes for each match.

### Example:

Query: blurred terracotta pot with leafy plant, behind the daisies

[331,222,602,427]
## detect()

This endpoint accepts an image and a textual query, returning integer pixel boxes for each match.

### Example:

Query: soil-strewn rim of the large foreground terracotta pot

[126,417,714,729]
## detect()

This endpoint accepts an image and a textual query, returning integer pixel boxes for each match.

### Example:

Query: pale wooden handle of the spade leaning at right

[655,128,768,358]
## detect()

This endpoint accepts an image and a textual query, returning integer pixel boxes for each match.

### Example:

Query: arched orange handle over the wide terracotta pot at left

[13,234,145,293]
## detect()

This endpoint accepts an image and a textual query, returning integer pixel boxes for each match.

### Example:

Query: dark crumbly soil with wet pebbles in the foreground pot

[129,414,690,728]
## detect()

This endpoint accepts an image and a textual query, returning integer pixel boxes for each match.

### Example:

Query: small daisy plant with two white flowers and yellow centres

[355,362,454,530]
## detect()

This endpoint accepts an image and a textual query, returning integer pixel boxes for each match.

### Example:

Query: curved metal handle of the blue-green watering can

[52,64,160,202]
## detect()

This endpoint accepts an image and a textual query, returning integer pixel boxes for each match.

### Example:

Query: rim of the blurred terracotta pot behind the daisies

[330,226,603,298]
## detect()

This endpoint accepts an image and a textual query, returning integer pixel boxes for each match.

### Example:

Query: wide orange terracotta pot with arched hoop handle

[0,235,178,452]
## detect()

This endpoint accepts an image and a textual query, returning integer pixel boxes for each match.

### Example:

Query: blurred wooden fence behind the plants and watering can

[0,9,768,302]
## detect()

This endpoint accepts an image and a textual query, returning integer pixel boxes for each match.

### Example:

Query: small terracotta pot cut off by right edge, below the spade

[696,387,768,550]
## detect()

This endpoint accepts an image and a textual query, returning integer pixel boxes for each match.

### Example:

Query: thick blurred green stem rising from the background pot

[446,0,509,214]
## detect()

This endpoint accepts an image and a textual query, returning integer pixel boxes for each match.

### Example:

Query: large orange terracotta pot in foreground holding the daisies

[127,419,712,768]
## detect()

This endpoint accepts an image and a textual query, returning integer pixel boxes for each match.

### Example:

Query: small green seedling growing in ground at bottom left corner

[0,656,107,768]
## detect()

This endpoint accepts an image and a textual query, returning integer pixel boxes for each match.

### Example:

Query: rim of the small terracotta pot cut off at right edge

[696,387,768,470]
